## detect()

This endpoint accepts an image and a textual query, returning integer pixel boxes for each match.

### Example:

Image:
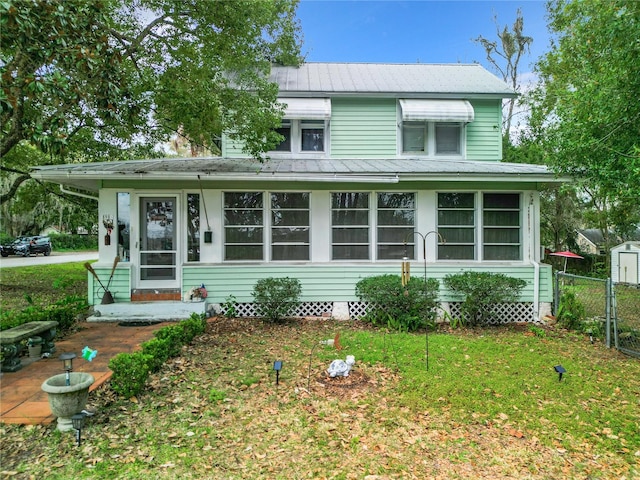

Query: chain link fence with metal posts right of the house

[554,272,640,357]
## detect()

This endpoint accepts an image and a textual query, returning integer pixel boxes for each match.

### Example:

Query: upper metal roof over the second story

[270,63,516,98]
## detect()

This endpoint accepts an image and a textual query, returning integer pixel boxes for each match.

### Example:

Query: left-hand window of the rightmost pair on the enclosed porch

[438,192,476,260]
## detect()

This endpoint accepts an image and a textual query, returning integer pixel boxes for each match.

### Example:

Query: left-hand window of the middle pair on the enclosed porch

[331,192,370,260]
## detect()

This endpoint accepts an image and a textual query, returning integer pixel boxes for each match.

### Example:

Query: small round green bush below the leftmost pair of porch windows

[253,277,302,322]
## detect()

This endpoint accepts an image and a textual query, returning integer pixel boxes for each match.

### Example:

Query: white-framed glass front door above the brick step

[138,197,179,288]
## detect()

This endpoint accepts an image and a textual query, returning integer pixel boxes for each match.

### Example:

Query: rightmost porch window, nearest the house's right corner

[482,193,522,260]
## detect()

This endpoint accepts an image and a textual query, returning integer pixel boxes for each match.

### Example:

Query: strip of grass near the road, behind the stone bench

[0,262,87,312]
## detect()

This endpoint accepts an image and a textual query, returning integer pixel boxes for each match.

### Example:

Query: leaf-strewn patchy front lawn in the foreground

[0,319,640,479]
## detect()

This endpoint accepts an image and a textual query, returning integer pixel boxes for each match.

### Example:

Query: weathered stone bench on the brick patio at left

[0,321,58,372]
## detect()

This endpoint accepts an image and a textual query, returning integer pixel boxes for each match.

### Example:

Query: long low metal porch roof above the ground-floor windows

[33,157,569,192]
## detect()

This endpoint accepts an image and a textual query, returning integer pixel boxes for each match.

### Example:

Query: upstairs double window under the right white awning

[400,99,474,156]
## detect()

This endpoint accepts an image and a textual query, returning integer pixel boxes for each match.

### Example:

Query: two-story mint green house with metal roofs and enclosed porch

[34,63,560,320]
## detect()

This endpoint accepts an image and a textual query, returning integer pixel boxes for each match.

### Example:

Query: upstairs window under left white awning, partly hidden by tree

[275,98,331,154]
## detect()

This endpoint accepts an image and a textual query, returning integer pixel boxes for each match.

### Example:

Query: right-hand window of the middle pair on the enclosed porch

[376,193,415,260]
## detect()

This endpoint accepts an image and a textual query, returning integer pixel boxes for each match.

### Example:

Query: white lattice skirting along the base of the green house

[220,302,538,325]
